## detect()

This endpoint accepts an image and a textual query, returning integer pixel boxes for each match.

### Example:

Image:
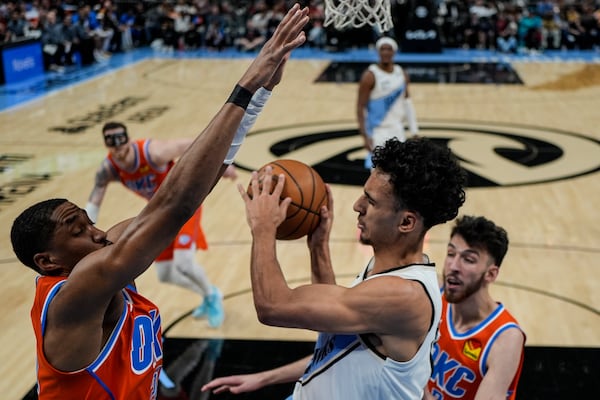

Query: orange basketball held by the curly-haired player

[248,160,327,240]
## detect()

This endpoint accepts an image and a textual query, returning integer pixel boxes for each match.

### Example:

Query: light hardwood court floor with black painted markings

[0,51,600,399]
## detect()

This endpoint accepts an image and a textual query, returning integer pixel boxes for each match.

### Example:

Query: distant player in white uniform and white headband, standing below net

[356,37,419,168]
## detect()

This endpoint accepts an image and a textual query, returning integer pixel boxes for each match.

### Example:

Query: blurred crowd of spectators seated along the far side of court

[0,0,600,69]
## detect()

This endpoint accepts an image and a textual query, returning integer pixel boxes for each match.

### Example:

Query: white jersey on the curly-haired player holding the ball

[292,263,442,400]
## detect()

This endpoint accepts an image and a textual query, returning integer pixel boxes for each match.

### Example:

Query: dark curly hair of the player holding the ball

[373,137,466,229]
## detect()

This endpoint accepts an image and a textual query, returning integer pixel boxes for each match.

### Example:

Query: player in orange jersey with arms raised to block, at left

[11,4,308,400]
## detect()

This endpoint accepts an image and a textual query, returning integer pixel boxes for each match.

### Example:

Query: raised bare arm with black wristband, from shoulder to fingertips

[45,5,308,371]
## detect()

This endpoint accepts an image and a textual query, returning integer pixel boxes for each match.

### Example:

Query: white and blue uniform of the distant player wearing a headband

[366,64,406,146]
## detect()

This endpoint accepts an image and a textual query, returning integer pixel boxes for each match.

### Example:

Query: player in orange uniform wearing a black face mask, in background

[85,122,239,328]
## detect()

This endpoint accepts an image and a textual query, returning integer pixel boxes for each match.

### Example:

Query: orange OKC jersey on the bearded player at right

[428,296,525,400]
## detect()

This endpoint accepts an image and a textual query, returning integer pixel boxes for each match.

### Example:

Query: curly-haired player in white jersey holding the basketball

[202,138,465,400]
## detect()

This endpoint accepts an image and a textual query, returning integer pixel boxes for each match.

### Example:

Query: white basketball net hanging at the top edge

[323,0,394,33]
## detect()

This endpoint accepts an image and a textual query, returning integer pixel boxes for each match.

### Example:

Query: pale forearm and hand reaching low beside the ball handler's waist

[202,356,311,394]
